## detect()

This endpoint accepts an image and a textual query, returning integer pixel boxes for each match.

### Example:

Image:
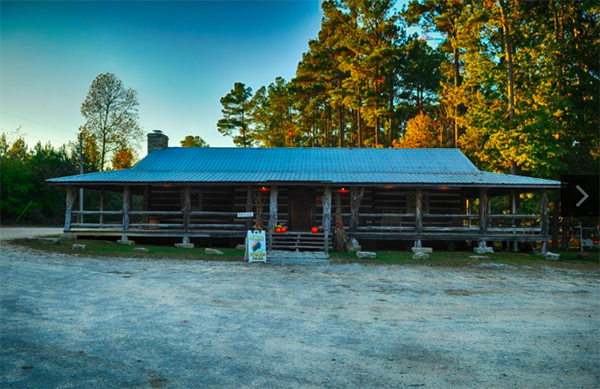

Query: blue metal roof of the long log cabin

[48,147,560,188]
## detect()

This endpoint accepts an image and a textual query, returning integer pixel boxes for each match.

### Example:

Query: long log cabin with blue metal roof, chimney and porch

[48,131,560,252]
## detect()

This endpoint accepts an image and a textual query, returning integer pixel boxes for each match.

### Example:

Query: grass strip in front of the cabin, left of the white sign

[10,239,244,261]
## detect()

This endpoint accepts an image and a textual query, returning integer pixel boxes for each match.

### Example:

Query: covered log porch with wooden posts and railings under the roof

[64,182,548,252]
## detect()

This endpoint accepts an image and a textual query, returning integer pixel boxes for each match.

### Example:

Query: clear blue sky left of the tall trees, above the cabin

[0,1,412,156]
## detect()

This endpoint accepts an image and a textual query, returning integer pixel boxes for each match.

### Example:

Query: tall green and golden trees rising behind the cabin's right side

[217,0,600,178]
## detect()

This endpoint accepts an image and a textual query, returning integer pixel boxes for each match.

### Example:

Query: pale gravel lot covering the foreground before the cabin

[0,232,600,389]
